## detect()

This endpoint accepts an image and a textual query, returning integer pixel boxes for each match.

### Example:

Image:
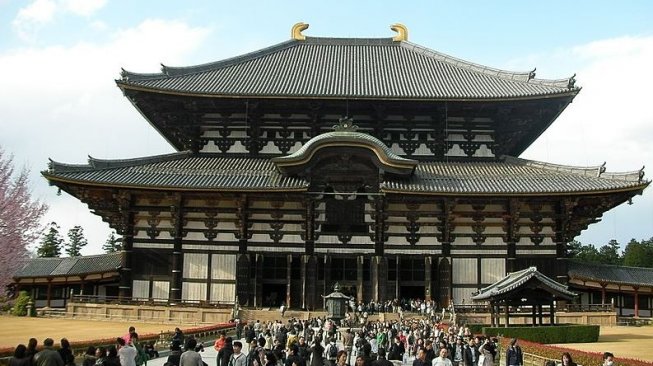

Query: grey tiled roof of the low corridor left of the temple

[13,253,121,278]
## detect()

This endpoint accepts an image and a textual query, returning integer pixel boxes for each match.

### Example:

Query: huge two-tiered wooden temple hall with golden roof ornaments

[43,23,650,309]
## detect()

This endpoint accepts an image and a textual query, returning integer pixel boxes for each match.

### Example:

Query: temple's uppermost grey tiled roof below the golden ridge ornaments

[117,37,580,100]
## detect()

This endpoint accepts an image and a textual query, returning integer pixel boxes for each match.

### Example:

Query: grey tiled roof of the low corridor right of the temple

[567,260,653,287]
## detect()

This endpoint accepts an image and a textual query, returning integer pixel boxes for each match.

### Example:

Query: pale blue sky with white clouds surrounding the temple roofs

[0,0,653,254]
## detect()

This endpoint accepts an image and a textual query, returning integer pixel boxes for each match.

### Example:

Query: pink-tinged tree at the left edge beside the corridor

[0,148,48,289]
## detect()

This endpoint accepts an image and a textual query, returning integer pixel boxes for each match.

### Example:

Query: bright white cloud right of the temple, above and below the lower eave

[523,36,653,245]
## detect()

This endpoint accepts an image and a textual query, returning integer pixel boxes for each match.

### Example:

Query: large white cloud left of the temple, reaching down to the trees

[0,19,210,254]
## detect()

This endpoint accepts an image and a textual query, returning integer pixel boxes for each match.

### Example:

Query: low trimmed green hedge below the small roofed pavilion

[483,324,600,344]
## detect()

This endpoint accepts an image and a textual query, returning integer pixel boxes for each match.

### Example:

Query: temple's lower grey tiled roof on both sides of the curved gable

[43,153,650,195]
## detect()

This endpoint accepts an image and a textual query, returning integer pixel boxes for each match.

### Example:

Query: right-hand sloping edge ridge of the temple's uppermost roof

[400,41,580,90]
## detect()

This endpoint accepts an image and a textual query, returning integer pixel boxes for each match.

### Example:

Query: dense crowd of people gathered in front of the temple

[9,317,614,366]
